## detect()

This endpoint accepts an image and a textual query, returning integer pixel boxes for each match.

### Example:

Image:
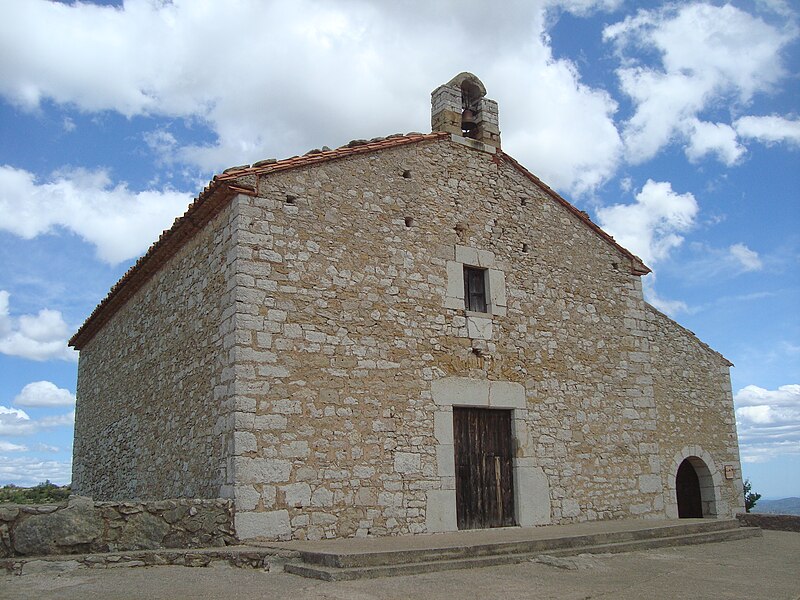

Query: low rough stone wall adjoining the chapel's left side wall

[0,496,235,557]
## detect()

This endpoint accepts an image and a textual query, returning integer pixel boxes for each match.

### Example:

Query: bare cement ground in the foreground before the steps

[0,531,800,600]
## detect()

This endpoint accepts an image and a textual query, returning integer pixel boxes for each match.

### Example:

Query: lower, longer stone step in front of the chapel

[284,527,762,581]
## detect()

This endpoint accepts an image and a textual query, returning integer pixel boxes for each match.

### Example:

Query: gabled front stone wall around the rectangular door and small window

[231,141,664,538]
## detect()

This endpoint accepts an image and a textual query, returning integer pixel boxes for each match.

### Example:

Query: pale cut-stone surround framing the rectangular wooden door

[426,377,550,533]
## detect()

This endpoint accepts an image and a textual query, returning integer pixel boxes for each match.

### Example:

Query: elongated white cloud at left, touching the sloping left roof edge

[0,165,191,264]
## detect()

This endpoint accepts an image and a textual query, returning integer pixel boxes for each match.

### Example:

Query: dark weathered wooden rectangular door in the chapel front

[453,407,516,529]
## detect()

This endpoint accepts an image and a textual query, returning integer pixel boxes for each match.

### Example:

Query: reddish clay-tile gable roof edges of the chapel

[69,131,650,350]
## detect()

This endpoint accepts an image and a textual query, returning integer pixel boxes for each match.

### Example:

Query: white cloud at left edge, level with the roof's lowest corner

[0,290,78,361]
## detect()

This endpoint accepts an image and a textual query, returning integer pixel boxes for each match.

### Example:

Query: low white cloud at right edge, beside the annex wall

[734,384,800,463]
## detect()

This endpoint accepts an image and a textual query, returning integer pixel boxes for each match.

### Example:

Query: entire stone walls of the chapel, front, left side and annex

[73,76,742,539]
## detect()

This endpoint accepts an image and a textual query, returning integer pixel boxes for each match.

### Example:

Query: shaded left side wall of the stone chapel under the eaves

[72,204,235,500]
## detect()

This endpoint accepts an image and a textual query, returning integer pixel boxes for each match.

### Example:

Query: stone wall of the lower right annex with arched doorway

[647,305,744,517]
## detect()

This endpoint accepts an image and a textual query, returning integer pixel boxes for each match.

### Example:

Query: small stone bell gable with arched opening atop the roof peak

[431,73,500,148]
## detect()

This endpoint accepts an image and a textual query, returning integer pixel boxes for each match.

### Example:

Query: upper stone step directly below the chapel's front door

[300,519,740,568]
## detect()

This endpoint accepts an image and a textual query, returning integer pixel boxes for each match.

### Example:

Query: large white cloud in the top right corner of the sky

[603,3,796,164]
